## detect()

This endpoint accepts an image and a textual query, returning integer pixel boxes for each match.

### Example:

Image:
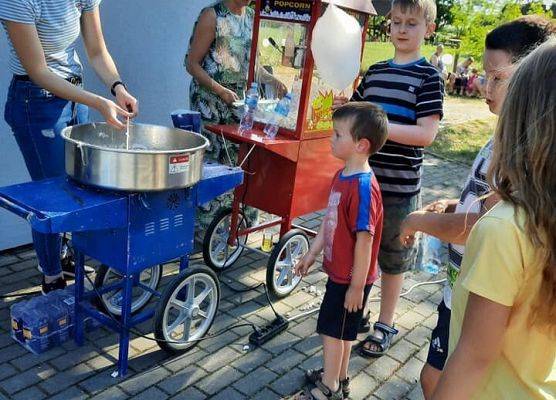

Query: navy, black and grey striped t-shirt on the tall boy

[352,58,444,197]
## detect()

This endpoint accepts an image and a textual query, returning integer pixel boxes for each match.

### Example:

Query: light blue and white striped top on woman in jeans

[0,0,101,78]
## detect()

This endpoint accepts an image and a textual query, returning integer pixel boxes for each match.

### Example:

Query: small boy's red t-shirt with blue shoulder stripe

[322,170,383,284]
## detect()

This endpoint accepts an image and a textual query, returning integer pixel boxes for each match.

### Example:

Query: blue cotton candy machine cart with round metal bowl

[0,113,243,376]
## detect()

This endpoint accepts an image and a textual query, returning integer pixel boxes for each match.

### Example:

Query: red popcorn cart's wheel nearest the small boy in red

[266,229,309,298]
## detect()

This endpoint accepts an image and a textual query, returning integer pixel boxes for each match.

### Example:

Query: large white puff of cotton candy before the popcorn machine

[311,4,362,90]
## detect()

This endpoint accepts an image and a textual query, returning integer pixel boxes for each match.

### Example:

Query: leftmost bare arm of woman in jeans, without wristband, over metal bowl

[5,21,131,129]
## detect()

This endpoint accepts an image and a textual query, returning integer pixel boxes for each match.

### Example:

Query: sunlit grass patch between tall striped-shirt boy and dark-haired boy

[428,118,496,165]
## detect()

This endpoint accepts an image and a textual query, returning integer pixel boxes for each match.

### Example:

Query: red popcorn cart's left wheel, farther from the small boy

[203,207,247,272]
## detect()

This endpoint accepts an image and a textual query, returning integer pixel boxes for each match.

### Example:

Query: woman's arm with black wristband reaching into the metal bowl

[81,7,139,116]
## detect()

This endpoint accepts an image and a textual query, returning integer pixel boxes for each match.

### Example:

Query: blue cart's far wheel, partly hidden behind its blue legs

[95,264,162,316]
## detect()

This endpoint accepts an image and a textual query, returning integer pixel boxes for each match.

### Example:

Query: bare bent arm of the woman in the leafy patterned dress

[185,8,239,104]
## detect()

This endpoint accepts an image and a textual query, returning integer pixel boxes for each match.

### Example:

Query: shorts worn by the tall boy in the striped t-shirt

[378,194,421,275]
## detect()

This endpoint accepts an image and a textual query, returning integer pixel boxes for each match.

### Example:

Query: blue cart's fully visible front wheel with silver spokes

[154,267,220,352]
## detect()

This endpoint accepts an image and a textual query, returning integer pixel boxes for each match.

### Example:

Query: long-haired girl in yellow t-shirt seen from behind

[433,38,556,400]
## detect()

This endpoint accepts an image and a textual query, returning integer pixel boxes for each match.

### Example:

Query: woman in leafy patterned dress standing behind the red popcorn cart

[184,0,286,232]
